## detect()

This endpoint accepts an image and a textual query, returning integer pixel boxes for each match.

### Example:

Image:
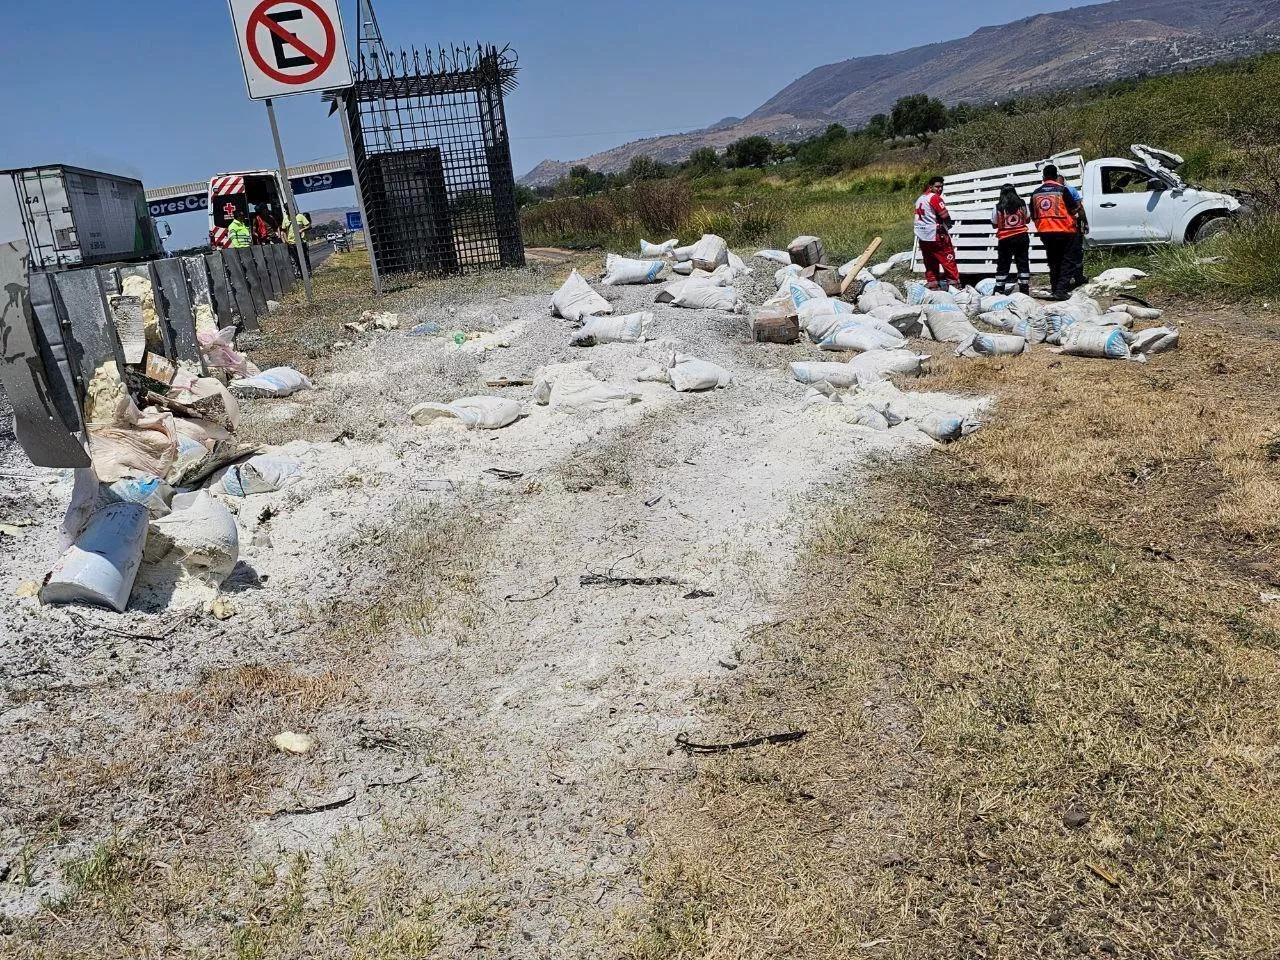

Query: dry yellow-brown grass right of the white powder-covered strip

[630,316,1280,960]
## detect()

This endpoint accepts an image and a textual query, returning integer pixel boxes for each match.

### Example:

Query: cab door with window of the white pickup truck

[1085,160,1183,244]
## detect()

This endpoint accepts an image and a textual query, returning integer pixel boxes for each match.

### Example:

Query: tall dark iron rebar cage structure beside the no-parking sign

[344,45,525,275]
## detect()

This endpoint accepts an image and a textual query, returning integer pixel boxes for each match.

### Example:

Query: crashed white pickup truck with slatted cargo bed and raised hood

[913,143,1240,276]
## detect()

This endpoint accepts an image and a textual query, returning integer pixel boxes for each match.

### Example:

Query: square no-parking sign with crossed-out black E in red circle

[228,0,352,100]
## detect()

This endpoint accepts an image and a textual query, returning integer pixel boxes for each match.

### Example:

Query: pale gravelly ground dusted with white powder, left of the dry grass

[0,261,978,957]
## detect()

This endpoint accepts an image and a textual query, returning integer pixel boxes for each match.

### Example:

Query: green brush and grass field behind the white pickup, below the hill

[521,55,1280,300]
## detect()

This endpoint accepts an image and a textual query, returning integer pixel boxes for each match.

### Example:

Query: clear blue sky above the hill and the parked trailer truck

[0,0,1080,243]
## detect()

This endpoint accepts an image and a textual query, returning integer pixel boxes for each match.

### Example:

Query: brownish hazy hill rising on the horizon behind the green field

[521,0,1280,187]
